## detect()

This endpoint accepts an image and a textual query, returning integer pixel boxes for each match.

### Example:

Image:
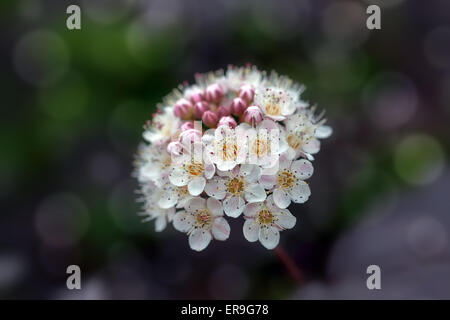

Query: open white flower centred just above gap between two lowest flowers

[205,164,267,218]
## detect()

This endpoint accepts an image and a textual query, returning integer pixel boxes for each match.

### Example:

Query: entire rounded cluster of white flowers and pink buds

[136,66,332,251]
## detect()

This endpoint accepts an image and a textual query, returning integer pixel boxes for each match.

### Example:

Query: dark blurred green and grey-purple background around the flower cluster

[0,0,450,299]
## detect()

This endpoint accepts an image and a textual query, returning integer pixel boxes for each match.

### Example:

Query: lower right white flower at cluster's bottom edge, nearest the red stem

[243,195,297,249]
